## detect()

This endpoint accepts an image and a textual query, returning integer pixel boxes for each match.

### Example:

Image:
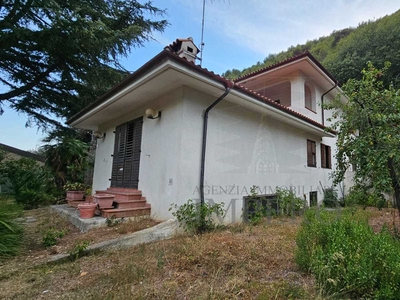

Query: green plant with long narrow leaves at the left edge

[0,198,22,259]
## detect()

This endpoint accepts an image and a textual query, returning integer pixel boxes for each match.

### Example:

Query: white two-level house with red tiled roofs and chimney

[68,38,346,222]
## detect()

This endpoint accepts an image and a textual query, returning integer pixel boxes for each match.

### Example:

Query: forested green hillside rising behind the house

[223,10,400,88]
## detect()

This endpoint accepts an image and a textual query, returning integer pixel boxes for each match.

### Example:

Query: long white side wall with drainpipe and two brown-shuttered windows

[179,88,335,222]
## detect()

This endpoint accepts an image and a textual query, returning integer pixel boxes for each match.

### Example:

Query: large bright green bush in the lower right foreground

[295,209,400,299]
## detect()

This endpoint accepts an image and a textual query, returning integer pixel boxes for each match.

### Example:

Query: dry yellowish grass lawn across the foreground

[0,218,320,299]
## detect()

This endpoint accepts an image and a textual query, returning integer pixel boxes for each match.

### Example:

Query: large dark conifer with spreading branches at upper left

[0,0,168,126]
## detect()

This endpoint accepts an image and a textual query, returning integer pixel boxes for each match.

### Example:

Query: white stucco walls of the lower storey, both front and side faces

[93,87,342,222]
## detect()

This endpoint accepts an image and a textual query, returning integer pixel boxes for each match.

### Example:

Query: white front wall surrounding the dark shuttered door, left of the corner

[93,88,183,219]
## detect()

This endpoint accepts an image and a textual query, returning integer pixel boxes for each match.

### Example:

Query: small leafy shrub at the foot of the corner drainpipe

[169,199,225,234]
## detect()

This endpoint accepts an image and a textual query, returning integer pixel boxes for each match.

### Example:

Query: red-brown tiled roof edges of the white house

[67,45,336,134]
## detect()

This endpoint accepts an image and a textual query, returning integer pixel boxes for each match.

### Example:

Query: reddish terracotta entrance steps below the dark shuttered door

[96,188,151,218]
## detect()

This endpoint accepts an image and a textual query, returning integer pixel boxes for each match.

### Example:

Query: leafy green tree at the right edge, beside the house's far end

[329,62,400,212]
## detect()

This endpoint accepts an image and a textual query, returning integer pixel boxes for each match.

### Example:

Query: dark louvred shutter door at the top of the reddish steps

[111,117,143,189]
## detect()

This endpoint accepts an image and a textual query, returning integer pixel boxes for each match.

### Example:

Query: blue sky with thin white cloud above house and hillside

[0,0,400,150]
